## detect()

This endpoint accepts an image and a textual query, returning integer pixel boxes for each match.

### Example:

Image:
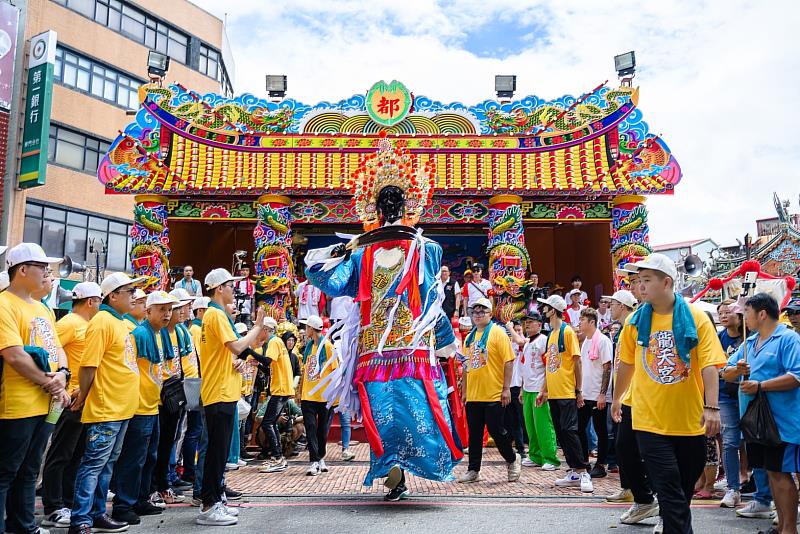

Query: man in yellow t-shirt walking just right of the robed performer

[458,298,522,484]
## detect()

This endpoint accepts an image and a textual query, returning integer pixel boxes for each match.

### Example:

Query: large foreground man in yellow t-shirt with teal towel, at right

[612,254,726,532]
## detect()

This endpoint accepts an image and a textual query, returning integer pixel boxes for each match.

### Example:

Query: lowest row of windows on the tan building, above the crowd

[23,202,131,271]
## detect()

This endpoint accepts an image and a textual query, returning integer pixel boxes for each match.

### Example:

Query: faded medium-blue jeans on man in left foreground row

[70,419,130,526]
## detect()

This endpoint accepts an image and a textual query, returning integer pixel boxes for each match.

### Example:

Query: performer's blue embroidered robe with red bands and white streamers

[305,233,463,485]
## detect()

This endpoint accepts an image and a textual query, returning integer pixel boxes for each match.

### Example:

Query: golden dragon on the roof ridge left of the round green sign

[147,86,294,133]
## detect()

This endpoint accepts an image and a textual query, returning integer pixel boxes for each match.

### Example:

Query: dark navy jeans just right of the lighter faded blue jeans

[114,415,159,512]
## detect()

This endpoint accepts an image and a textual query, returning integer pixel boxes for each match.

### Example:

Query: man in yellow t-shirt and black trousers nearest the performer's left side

[259,317,294,473]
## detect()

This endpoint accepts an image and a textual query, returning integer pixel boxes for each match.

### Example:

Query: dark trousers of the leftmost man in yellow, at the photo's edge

[0,415,54,532]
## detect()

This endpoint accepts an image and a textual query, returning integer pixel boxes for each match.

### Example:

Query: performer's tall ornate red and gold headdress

[350,131,436,230]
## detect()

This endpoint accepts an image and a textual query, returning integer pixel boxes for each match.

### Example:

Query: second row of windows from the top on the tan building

[54,46,142,109]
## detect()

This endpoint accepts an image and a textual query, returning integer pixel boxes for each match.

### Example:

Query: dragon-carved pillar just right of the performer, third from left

[488,204,531,324]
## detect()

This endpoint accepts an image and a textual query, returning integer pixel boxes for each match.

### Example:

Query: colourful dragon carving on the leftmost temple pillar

[130,201,169,291]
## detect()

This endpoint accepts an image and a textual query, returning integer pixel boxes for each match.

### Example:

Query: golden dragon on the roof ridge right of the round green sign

[486,87,634,135]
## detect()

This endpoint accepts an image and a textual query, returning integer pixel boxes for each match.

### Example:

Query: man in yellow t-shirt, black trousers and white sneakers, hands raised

[196,268,264,526]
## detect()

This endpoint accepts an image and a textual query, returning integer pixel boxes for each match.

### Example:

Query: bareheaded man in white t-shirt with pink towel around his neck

[578,308,613,478]
